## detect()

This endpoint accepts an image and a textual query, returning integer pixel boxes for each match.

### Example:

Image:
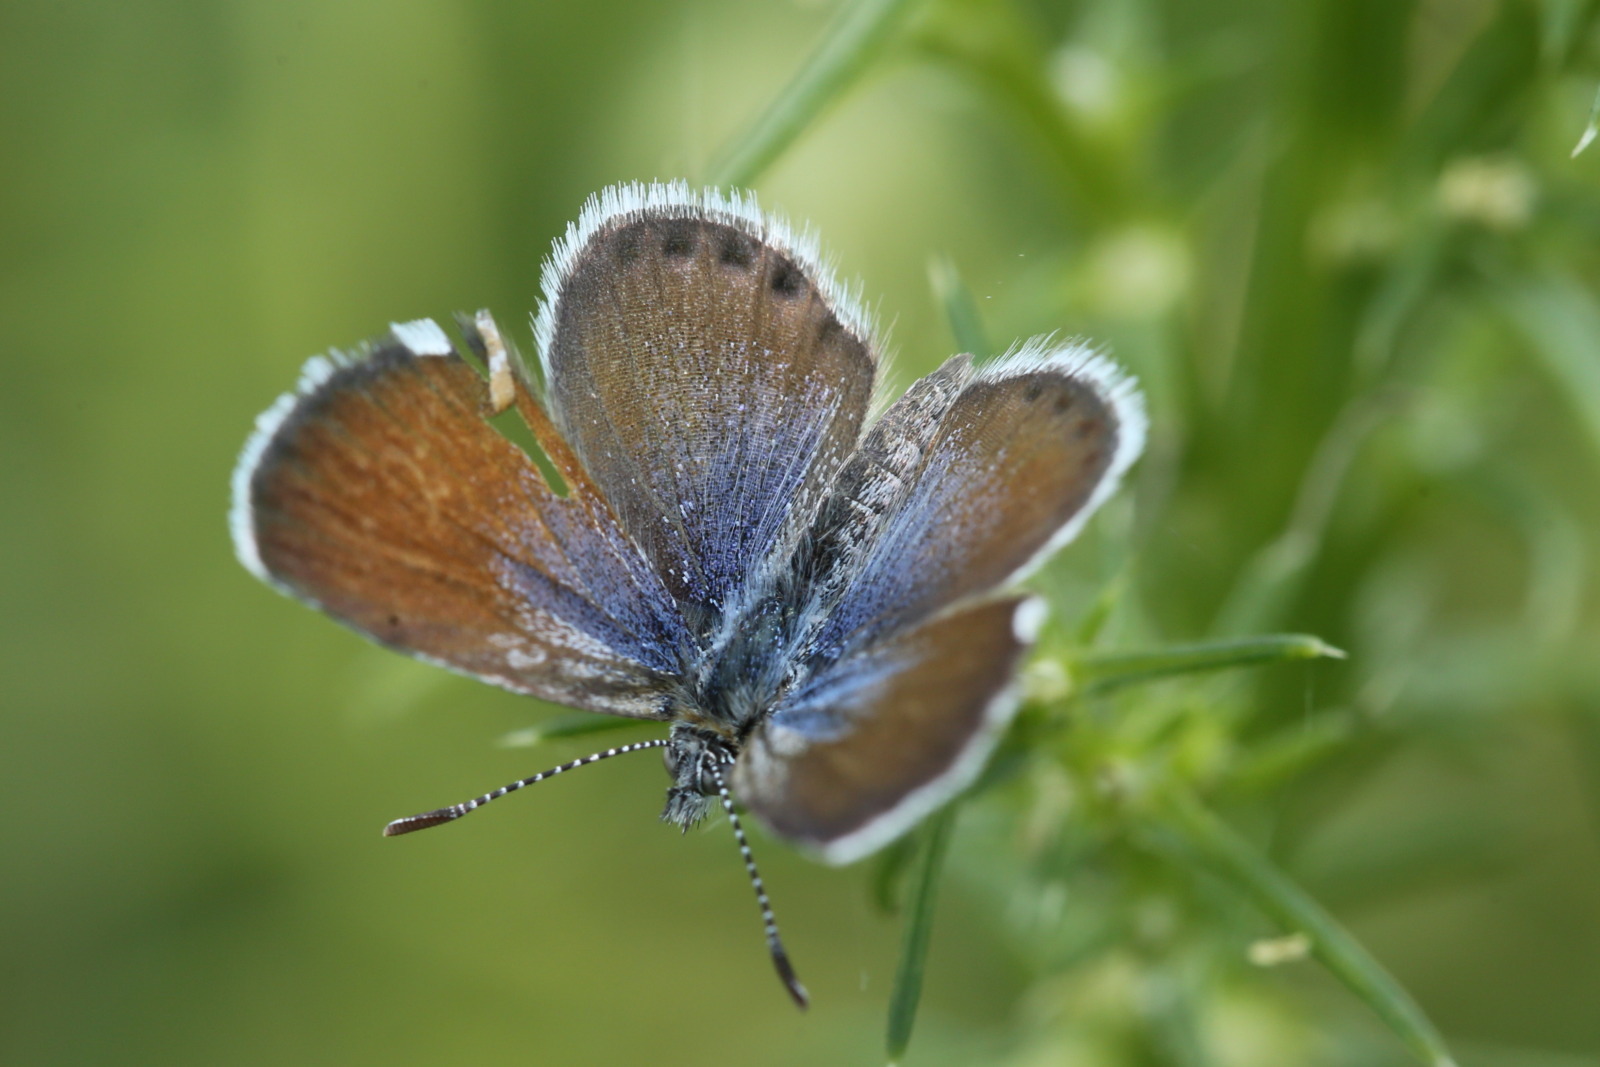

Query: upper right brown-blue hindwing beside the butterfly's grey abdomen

[808,347,1144,664]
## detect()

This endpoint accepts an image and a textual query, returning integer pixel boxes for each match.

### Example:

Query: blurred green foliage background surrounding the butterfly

[0,0,1600,1067]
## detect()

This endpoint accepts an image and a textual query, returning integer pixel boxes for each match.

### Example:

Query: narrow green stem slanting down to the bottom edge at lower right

[1165,790,1456,1067]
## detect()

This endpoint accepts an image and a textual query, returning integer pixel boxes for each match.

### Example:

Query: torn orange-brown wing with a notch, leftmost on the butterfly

[232,320,683,718]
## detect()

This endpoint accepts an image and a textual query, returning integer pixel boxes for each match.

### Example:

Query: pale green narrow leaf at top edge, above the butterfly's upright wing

[709,0,922,186]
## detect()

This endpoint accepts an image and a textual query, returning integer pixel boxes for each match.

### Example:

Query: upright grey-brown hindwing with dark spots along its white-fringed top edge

[538,186,875,629]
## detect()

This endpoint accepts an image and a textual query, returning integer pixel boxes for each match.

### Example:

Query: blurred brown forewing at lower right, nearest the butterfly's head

[733,597,1043,864]
